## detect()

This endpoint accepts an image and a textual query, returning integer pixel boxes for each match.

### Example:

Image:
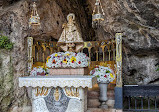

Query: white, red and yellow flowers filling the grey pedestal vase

[90,66,115,83]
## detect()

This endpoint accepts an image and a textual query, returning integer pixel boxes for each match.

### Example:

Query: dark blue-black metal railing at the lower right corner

[123,85,159,112]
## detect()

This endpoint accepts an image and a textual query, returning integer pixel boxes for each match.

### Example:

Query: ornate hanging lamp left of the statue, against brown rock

[29,2,40,27]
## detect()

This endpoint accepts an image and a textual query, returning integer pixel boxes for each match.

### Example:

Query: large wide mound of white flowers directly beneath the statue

[46,52,90,68]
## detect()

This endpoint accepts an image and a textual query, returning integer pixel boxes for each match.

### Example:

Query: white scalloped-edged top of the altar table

[19,75,97,88]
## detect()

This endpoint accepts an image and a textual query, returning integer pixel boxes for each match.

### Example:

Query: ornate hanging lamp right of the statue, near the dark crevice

[92,0,105,28]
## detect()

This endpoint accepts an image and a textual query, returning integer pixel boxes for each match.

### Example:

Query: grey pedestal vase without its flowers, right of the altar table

[98,82,108,109]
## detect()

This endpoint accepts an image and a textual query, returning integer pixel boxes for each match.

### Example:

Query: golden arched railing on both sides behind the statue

[32,40,116,63]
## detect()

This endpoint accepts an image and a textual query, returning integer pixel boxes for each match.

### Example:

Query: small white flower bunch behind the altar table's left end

[30,67,48,76]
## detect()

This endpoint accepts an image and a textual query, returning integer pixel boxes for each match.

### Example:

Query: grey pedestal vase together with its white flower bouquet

[90,66,115,108]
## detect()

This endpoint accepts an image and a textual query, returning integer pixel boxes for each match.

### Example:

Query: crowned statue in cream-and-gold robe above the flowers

[58,13,83,52]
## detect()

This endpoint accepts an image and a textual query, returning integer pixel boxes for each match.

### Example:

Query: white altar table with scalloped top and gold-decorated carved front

[19,75,97,112]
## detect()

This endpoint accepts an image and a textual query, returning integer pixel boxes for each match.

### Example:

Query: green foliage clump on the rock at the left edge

[0,34,13,50]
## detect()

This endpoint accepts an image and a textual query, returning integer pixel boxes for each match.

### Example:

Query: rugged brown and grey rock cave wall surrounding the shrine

[0,0,159,112]
